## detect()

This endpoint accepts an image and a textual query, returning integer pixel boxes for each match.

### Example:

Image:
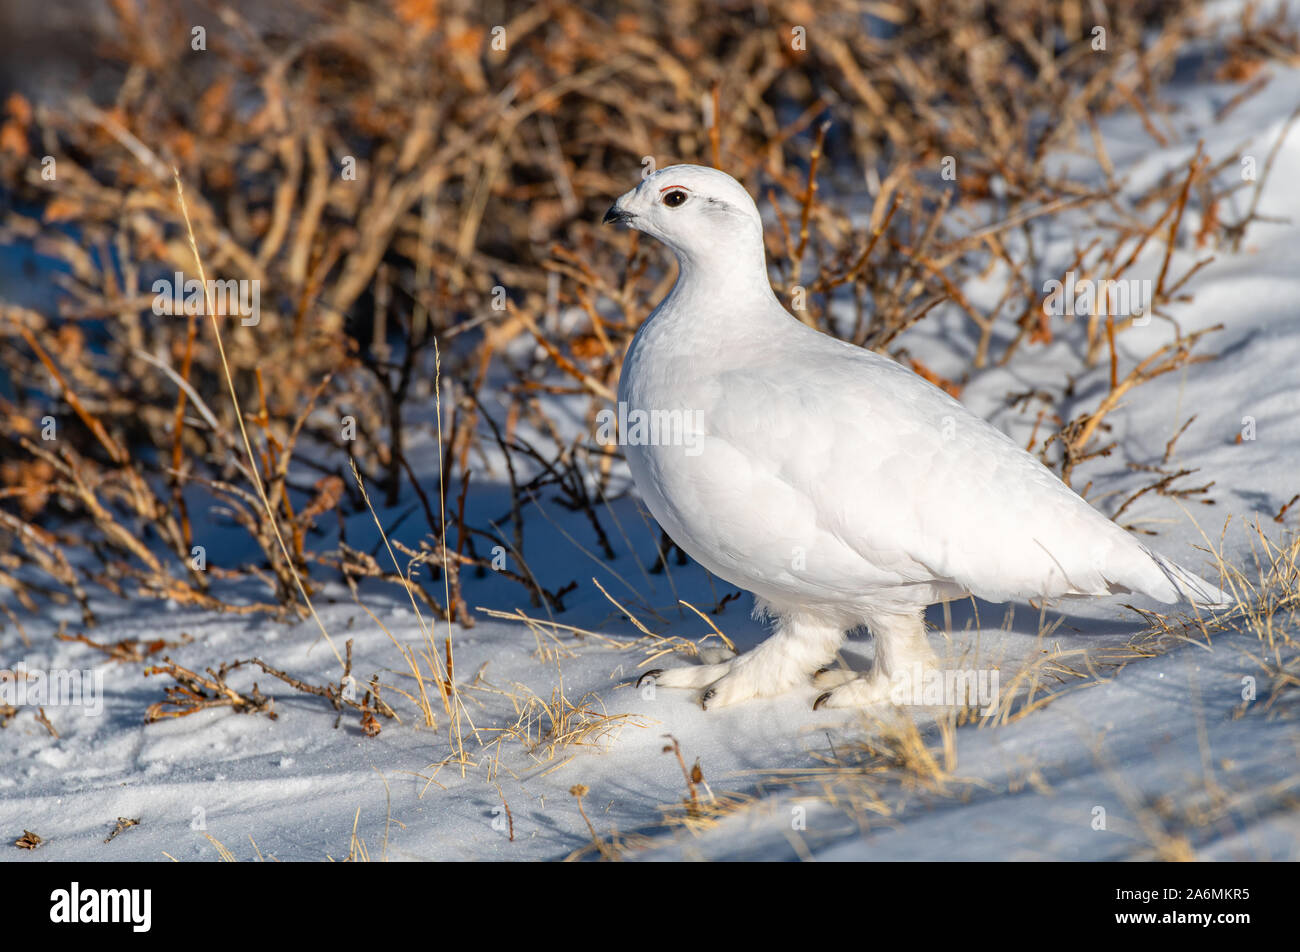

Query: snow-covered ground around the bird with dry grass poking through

[0,16,1300,862]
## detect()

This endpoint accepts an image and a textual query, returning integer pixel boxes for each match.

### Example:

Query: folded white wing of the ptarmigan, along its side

[705,332,1217,602]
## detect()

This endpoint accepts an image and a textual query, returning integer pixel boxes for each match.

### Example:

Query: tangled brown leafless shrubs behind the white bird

[0,0,1294,624]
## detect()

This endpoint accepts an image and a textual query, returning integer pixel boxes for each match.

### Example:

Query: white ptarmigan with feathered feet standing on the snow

[605,165,1226,707]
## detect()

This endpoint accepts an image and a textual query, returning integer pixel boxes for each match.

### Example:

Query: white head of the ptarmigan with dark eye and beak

[605,165,763,265]
